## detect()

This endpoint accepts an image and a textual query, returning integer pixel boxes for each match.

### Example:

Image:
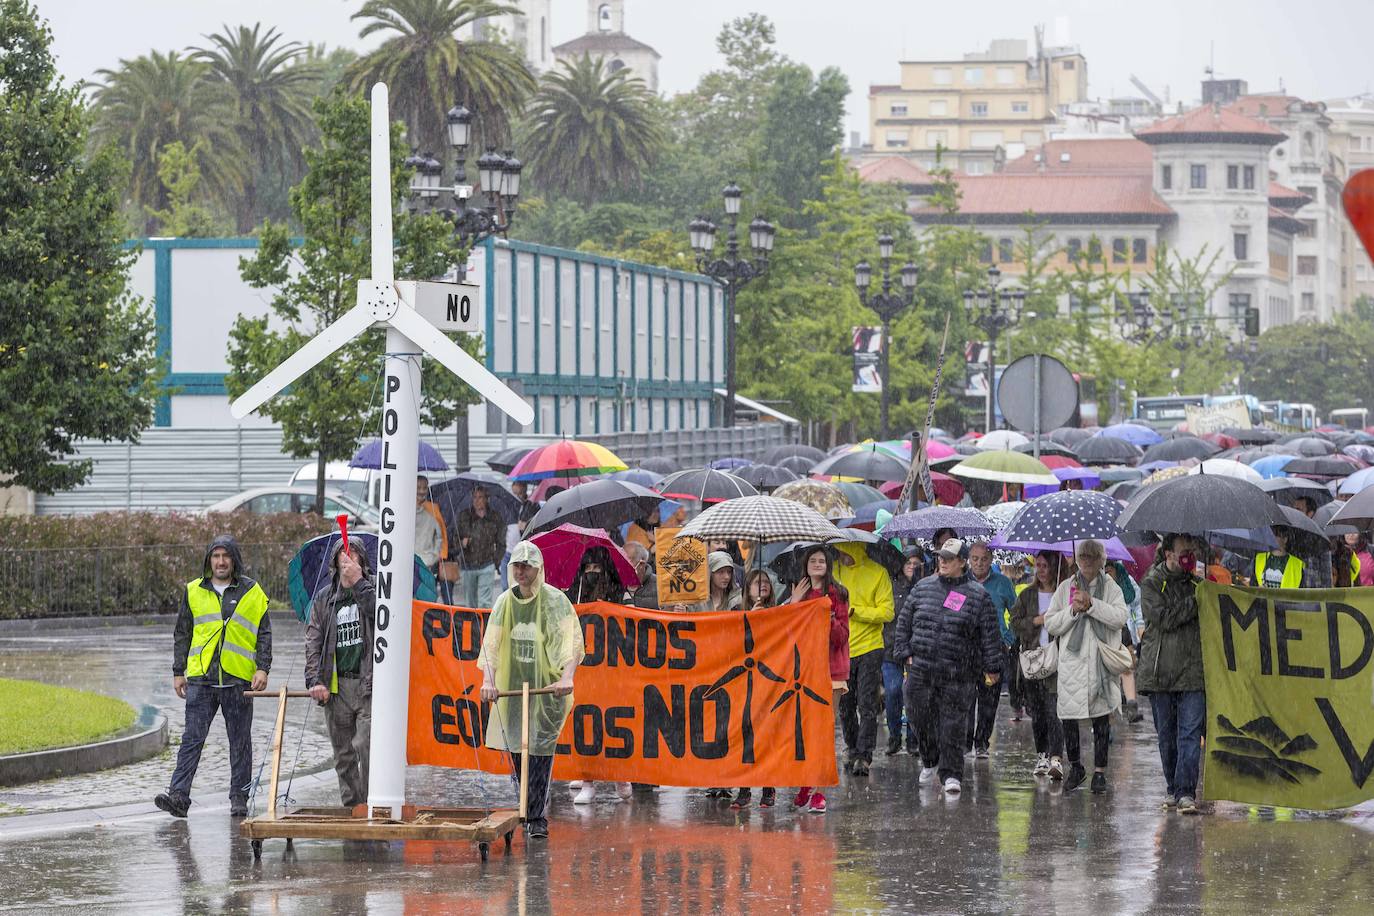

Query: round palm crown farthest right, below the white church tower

[521,55,665,203]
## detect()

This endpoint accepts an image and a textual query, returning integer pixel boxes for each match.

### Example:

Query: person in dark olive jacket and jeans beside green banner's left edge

[1135,534,1206,814]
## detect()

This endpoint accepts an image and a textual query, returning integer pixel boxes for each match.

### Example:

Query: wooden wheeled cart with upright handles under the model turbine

[239,684,541,862]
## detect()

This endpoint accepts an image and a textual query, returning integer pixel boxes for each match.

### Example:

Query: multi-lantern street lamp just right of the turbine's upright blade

[405,104,525,282]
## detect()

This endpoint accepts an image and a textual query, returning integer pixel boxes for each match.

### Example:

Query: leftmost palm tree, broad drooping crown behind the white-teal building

[91,51,246,232]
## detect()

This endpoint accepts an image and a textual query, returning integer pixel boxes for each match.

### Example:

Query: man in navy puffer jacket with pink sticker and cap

[893,537,1002,795]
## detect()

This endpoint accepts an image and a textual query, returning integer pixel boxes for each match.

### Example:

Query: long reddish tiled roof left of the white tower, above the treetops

[912,173,1173,222]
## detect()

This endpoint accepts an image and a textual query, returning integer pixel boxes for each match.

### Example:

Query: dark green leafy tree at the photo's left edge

[0,0,159,493]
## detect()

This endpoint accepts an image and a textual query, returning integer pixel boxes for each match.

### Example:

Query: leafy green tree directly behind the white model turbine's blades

[225,95,480,505]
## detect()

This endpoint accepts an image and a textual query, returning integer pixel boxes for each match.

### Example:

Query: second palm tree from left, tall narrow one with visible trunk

[192,23,319,232]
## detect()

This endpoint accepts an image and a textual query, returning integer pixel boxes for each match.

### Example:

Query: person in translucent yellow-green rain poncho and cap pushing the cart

[477,541,585,838]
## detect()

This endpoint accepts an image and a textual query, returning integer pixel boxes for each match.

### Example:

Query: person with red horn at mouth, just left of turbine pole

[305,540,376,808]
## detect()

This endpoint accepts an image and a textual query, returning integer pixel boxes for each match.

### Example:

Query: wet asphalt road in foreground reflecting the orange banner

[0,620,1374,916]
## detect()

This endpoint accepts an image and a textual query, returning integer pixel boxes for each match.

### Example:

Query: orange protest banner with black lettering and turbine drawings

[407,600,838,786]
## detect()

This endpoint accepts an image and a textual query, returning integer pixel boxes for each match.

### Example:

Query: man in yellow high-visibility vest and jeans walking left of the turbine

[154,534,272,817]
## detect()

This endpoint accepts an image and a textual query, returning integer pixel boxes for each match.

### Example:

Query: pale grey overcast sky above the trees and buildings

[37,0,1374,140]
